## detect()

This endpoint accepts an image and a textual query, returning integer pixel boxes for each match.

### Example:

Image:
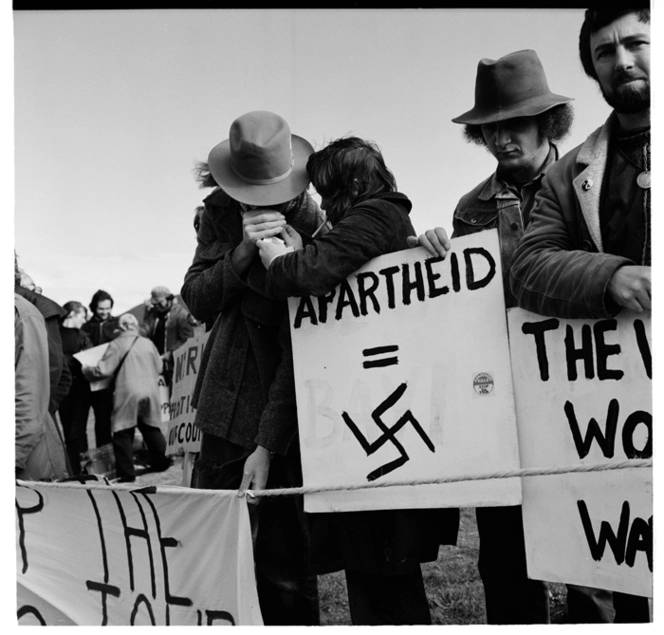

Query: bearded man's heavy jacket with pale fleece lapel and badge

[510,114,636,319]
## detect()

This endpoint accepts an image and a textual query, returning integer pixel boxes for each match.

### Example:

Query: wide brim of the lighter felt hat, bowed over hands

[208,134,314,206]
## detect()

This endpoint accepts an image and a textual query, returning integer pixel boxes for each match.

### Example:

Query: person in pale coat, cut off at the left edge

[14,293,68,481]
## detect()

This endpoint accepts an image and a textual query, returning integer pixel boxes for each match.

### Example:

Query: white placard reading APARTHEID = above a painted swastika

[289,231,521,512]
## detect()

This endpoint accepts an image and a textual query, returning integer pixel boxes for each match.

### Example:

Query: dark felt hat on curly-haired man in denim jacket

[452,50,573,125]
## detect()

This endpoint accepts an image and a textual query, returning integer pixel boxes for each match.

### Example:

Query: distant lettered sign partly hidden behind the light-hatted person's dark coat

[166,333,209,455]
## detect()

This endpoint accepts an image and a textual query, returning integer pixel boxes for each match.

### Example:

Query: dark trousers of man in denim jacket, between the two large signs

[475,505,551,624]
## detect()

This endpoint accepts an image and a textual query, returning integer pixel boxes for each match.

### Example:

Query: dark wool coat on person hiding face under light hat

[181,188,324,455]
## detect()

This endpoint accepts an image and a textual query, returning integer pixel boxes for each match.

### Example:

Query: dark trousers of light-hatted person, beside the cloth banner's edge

[192,433,320,626]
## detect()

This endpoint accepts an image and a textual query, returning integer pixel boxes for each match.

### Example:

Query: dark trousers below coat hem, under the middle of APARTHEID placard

[346,567,431,626]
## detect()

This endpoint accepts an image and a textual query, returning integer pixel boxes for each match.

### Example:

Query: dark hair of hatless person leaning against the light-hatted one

[307,137,397,223]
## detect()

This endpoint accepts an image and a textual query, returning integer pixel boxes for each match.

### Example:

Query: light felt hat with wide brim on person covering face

[208,110,314,205]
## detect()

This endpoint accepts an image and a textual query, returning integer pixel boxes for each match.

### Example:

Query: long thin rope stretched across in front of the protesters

[17,459,653,498]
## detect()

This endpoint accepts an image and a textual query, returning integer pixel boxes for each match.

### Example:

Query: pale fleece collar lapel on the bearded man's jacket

[572,113,616,252]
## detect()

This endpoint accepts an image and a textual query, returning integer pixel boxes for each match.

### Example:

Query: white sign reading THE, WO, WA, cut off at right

[508,309,653,596]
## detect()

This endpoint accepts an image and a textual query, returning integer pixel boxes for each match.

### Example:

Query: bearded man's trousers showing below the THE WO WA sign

[567,584,650,624]
